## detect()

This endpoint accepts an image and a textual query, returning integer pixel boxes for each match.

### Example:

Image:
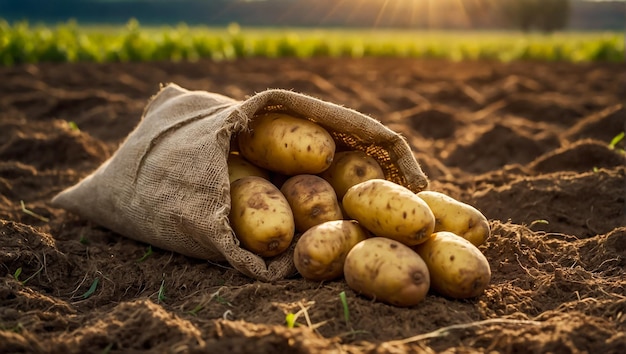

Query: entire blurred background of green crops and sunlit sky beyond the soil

[0,0,626,65]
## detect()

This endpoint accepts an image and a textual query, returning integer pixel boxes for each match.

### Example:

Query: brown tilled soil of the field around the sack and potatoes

[0,59,626,353]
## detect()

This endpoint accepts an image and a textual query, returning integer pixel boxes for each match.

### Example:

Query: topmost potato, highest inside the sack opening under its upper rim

[239,113,336,175]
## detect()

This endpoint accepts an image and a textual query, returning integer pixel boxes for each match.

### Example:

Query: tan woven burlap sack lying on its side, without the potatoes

[52,84,428,281]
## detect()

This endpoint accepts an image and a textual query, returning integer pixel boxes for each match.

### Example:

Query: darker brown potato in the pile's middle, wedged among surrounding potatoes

[280,175,343,232]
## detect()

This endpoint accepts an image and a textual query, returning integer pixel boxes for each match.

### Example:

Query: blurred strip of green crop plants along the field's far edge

[0,20,624,66]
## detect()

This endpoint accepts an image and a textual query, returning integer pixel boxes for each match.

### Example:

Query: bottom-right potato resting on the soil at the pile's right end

[414,231,491,299]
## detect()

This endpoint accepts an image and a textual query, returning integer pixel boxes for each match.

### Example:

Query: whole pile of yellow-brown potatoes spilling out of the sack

[228,112,491,306]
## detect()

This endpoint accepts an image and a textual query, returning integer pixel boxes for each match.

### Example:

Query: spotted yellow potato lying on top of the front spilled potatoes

[343,179,435,246]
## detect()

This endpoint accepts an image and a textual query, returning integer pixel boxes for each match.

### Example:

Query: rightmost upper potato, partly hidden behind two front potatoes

[417,191,491,246]
